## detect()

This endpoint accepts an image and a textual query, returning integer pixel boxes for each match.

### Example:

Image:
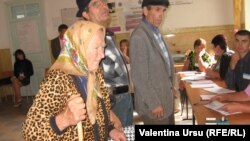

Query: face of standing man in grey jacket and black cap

[143,5,166,27]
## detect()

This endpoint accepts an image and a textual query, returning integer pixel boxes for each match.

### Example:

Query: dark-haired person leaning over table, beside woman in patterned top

[206,34,234,79]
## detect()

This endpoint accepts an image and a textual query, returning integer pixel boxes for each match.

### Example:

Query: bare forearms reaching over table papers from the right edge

[211,84,250,113]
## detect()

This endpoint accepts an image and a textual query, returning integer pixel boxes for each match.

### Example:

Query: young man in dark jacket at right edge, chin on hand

[225,30,250,91]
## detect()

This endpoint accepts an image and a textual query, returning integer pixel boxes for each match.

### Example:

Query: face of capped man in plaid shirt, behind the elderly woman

[83,0,110,27]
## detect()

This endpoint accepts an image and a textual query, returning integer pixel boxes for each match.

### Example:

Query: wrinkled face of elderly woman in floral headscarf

[86,31,105,71]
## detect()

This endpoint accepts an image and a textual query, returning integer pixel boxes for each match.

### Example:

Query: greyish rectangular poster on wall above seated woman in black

[16,20,41,53]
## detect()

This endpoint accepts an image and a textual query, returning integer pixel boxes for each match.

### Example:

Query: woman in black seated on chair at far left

[0,49,34,107]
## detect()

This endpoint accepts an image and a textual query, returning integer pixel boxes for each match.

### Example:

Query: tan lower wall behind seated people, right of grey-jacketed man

[165,25,234,54]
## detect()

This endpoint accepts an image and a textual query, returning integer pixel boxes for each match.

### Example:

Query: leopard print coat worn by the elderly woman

[22,70,111,141]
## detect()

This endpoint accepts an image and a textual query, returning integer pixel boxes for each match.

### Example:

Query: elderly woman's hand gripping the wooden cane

[56,95,86,131]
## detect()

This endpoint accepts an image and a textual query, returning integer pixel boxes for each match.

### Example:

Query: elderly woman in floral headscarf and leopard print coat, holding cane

[23,21,126,141]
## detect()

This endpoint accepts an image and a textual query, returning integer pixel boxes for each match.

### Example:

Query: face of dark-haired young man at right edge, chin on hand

[235,35,250,55]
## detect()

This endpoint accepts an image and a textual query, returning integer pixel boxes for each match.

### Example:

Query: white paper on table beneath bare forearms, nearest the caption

[204,101,241,116]
